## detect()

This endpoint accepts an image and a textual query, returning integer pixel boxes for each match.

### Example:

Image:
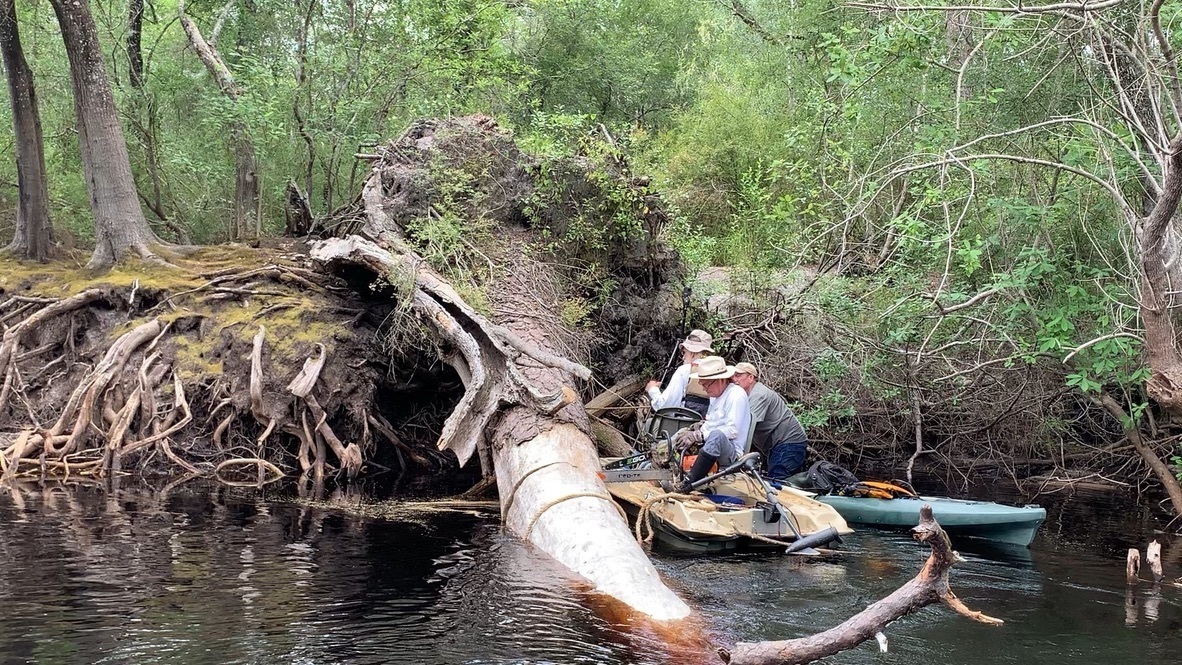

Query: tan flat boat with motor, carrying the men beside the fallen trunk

[608,460,853,554]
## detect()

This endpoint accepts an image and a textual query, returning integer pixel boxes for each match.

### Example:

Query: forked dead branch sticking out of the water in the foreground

[723,504,1002,665]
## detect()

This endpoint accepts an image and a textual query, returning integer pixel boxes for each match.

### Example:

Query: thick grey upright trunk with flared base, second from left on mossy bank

[51,0,160,268]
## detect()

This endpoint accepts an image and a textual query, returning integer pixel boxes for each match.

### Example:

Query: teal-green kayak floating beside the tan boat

[798,490,1046,547]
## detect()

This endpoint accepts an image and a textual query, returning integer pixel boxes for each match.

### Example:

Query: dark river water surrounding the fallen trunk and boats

[0,485,1182,665]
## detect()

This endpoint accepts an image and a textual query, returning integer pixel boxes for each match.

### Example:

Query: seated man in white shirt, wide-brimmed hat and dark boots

[676,356,751,491]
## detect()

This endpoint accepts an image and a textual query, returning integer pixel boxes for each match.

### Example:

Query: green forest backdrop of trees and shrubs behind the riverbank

[0,0,1182,510]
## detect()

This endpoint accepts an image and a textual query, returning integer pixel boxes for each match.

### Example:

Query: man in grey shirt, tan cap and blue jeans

[734,363,808,480]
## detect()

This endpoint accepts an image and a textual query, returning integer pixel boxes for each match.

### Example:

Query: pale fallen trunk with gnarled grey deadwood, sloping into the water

[311,233,690,620]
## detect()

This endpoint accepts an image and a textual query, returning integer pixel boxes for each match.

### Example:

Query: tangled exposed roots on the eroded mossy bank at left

[0,246,446,483]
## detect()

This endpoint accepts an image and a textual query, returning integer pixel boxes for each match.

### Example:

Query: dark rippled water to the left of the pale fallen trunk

[0,485,699,664]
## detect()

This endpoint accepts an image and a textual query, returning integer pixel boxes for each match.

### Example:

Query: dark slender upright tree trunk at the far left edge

[0,0,53,261]
